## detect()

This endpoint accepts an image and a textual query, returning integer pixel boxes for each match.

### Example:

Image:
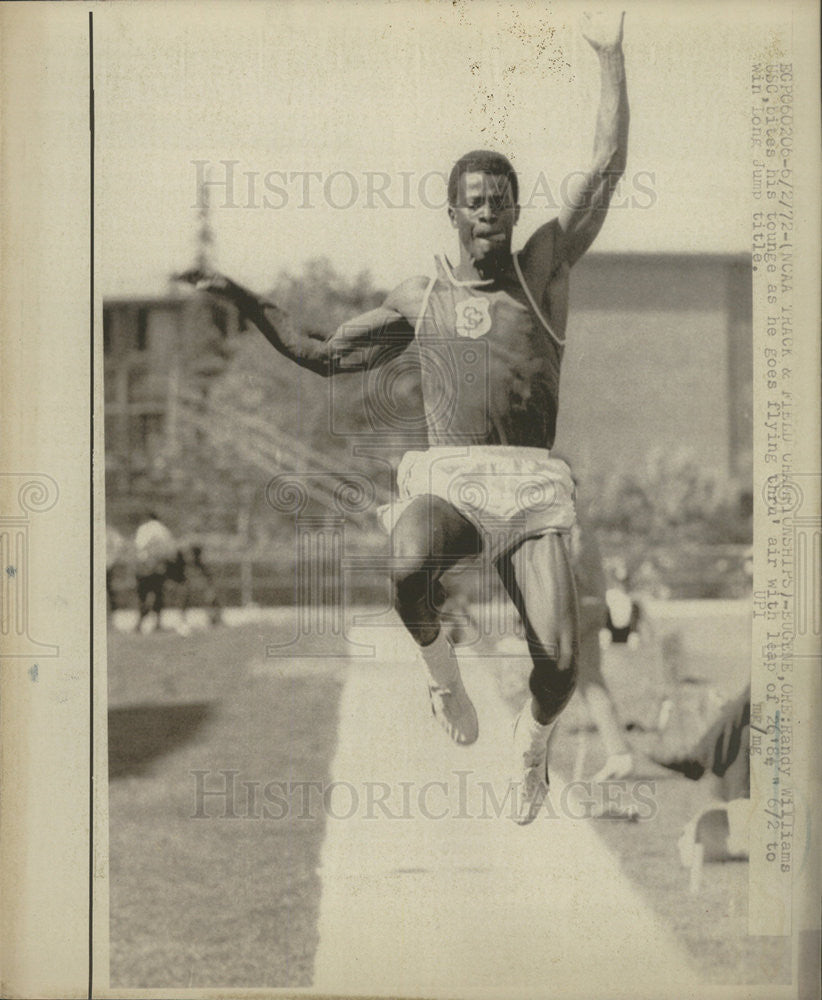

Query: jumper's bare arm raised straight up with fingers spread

[559,14,629,266]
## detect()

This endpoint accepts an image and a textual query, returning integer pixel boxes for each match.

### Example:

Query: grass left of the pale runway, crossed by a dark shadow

[109,626,341,987]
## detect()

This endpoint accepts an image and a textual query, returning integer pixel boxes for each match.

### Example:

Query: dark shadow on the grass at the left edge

[108,702,212,779]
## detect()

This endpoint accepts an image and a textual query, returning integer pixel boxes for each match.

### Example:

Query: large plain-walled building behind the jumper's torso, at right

[556,254,753,485]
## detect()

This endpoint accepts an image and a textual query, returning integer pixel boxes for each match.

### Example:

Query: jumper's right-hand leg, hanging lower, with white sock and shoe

[497,532,579,824]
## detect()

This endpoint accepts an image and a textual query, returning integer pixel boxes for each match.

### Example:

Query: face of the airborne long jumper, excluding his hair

[448,172,519,271]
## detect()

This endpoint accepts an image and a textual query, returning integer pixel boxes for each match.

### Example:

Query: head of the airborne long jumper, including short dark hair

[448,149,519,272]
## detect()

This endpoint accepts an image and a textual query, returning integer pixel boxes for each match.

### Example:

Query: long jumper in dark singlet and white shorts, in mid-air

[181,15,628,823]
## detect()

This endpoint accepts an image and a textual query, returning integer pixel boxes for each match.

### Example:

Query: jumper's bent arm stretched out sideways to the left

[177,269,427,376]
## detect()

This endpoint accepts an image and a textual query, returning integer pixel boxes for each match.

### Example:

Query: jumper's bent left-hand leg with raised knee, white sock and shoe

[391,496,482,744]
